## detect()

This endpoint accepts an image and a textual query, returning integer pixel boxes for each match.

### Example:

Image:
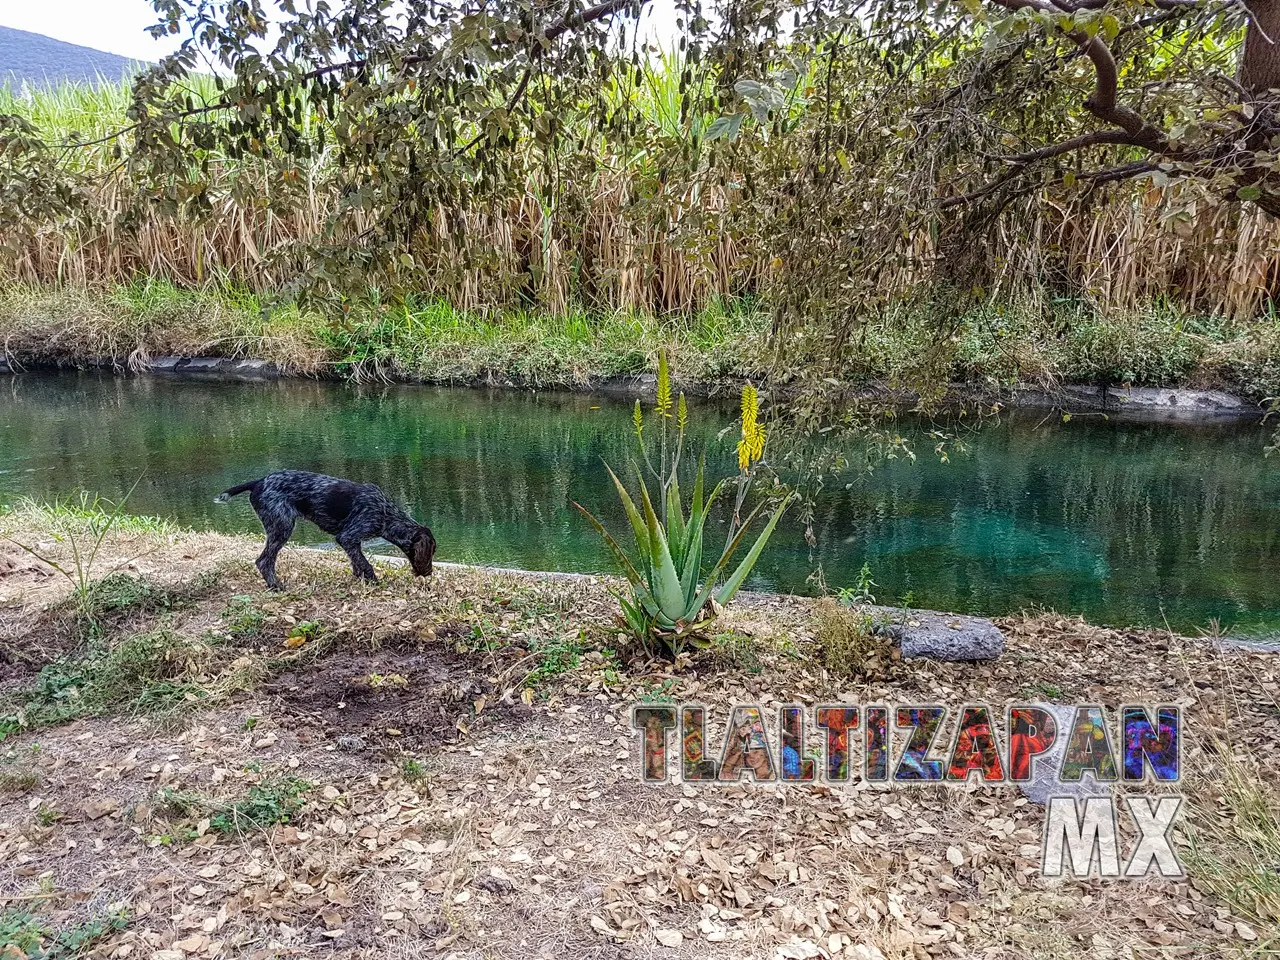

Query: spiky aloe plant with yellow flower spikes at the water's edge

[573,355,791,652]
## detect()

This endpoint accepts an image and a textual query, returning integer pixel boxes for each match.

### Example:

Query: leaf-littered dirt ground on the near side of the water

[0,517,1280,960]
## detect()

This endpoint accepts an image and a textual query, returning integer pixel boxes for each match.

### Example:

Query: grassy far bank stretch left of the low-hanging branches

[0,280,765,387]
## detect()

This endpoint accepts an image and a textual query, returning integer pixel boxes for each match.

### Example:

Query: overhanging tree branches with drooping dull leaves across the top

[0,0,1280,393]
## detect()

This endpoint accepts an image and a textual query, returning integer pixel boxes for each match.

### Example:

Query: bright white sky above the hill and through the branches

[0,0,691,65]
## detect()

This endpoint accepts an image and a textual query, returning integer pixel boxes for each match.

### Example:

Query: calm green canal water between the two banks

[0,374,1280,631]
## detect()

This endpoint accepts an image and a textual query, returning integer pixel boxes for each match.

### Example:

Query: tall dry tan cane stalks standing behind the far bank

[0,78,1280,330]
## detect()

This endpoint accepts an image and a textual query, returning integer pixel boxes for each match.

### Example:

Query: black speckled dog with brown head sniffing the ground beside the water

[214,470,435,590]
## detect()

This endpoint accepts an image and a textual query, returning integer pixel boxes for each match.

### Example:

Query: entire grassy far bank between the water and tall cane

[0,280,1280,399]
